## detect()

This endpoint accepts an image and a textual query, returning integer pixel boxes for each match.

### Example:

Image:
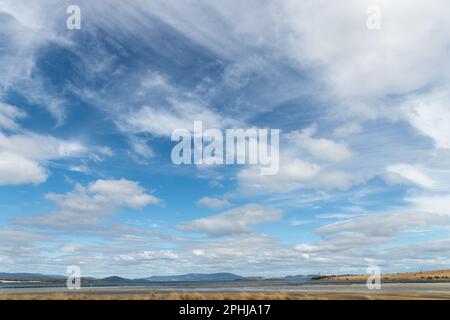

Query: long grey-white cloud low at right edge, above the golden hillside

[295,194,450,265]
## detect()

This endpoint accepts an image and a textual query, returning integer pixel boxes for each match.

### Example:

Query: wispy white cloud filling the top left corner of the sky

[0,0,70,124]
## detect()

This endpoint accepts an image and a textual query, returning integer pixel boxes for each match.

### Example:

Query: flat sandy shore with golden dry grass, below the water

[0,282,450,300]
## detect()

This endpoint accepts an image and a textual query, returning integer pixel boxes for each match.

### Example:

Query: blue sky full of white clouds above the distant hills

[0,0,450,278]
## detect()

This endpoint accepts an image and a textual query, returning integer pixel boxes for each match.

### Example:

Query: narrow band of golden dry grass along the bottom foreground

[0,292,450,300]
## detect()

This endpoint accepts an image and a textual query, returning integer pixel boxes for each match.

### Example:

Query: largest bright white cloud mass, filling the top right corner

[283,0,449,98]
